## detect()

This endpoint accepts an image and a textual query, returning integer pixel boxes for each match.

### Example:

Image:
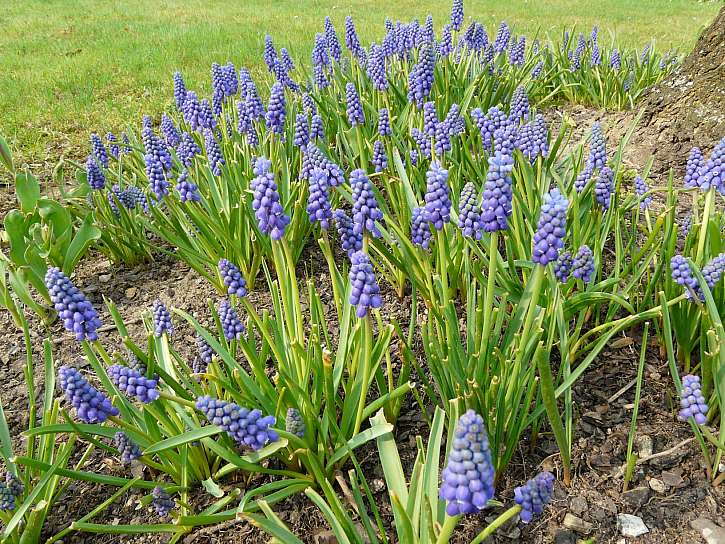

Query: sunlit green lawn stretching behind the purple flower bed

[0,0,722,167]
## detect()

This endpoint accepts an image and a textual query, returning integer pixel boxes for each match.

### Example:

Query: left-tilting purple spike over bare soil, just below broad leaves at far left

[45,267,101,342]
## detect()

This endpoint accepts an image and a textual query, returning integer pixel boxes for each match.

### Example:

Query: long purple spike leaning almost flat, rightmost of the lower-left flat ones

[196,396,279,451]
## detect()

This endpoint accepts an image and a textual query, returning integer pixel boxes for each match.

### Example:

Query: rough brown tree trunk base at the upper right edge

[642,7,725,172]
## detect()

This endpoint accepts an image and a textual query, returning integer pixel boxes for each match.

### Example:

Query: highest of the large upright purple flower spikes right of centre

[481,151,514,232]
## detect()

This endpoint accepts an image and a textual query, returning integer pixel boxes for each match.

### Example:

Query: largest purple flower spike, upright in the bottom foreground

[439,410,494,516]
